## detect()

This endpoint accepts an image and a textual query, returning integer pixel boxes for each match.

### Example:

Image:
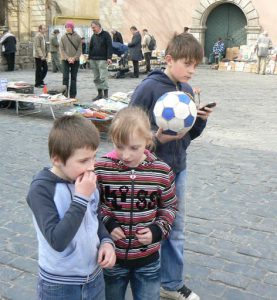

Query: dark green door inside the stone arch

[205,3,247,57]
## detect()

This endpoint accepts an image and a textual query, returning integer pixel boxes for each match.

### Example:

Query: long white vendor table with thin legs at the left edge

[0,92,77,119]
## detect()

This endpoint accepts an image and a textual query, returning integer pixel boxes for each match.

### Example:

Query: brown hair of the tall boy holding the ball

[165,33,204,64]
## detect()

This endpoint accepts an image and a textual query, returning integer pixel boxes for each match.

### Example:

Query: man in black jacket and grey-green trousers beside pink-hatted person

[89,21,113,101]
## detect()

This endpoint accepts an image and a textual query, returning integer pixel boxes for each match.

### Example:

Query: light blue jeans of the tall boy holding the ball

[161,170,186,291]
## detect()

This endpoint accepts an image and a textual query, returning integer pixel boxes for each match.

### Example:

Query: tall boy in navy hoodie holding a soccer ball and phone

[131,33,212,300]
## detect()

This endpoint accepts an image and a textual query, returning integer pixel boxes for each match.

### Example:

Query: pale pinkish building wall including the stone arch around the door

[100,0,277,49]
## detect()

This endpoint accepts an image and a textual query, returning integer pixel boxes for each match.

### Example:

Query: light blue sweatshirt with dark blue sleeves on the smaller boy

[27,168,112,284]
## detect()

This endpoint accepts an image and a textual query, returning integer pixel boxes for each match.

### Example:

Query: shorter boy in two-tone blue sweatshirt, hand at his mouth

[27,116,115,300]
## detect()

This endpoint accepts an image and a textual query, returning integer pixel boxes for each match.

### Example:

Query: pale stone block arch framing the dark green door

[190,0,261,46]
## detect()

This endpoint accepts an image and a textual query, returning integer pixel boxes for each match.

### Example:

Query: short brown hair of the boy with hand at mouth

[48,116,100,164]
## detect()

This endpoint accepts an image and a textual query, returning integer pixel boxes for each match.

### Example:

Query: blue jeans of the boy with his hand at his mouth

[37,272,105,300]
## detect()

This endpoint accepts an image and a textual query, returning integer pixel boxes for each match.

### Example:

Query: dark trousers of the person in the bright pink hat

[62,60,79,98]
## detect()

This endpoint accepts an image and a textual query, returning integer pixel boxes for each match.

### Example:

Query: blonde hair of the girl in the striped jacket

[109,106,154,147]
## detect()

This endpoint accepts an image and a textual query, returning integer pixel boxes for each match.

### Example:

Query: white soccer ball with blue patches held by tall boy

[153,91,197,134]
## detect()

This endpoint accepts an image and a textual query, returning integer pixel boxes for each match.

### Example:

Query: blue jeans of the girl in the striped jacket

[104,260,161,300]
